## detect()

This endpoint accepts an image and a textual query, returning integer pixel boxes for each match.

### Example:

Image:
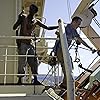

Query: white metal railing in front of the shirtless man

[0,36,59,84]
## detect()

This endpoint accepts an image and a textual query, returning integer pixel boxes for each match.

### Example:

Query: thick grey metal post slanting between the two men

[58,19,75,100]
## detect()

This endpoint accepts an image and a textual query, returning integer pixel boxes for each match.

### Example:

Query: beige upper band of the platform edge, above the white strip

[0,85,45,95]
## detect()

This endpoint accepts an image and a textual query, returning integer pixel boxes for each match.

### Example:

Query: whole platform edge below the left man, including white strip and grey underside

[0,85,52,100]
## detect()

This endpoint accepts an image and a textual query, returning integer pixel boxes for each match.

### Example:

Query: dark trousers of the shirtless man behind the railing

[18,43,38,77]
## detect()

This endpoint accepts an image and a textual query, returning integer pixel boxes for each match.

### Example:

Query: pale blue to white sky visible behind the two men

[39,0,100,76]
